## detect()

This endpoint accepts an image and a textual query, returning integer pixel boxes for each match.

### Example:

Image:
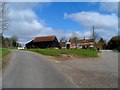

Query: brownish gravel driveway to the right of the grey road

[56,51,118,88]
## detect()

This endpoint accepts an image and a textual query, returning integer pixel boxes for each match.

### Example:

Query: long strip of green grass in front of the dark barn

[27,49,98,57]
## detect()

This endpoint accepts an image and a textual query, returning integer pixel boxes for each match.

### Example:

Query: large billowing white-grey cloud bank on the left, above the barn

[4,5,64,43]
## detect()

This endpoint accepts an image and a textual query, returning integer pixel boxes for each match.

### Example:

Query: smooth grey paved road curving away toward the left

[2,50,76,88]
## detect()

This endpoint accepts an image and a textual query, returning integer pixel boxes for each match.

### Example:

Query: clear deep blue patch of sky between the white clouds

[35,2,100,31]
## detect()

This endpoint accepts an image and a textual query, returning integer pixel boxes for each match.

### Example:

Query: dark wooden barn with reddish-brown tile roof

[26,36,61,49]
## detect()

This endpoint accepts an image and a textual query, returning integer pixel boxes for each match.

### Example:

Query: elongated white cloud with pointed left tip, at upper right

[65,12,118,29]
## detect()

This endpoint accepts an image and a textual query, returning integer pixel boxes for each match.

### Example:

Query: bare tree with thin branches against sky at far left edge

[0,2,9,36]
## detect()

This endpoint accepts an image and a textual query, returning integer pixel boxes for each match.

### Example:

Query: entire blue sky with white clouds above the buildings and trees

[4,2,118,44]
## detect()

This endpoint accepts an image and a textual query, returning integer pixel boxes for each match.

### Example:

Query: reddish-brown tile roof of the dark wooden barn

[33,36,56,42]
